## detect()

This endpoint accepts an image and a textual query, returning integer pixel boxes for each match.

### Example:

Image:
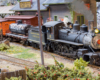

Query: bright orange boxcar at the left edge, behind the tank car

[0,19,16,36]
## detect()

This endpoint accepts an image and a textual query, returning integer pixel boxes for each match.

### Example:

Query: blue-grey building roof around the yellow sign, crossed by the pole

[11,0,48,11]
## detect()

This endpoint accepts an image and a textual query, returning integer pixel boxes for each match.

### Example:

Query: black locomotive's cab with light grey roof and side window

[42,21,64,39]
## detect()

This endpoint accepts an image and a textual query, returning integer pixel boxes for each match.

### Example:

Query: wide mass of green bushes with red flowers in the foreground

[25,58,100,80]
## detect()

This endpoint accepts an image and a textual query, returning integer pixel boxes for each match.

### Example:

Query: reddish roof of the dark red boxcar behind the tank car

[5,15,36,19]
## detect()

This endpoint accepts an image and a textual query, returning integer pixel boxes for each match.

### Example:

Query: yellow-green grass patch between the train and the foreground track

[4,45,35,59]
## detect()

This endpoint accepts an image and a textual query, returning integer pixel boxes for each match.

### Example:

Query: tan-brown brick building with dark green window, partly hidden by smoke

[73,0,97,27]
